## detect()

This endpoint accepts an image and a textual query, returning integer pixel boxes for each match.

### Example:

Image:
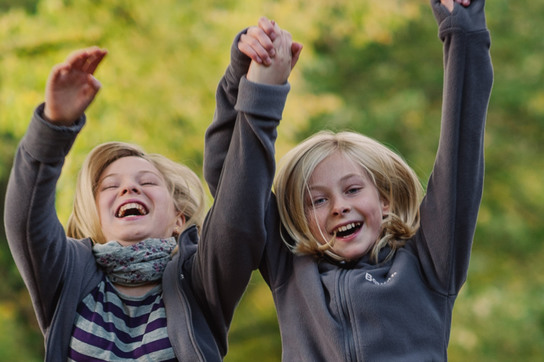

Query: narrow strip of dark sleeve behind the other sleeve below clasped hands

[203,29,251,197]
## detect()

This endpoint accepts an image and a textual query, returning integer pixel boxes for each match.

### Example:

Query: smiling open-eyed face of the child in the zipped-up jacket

[305,152,388,260]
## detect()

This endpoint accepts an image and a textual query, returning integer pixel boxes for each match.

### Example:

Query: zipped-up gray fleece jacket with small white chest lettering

[204,0,493,362]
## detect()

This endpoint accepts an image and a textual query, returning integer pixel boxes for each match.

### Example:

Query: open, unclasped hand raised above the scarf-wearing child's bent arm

[44,47,107,126]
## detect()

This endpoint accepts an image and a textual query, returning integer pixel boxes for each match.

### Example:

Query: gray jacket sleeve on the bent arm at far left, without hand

[4,105,85,331]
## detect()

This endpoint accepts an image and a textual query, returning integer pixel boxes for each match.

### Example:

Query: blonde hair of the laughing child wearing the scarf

[66,142,205,244]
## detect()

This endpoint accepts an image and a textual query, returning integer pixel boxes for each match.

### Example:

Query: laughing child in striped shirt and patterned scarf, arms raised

[4,16,302,361]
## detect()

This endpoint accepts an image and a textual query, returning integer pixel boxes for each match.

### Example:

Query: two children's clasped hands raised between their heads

[238,17,302,85]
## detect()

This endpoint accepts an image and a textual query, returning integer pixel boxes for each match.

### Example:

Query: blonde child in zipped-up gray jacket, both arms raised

[204,0,493,362]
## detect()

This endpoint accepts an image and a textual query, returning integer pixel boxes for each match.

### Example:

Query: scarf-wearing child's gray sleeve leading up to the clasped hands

[192,55,290,351]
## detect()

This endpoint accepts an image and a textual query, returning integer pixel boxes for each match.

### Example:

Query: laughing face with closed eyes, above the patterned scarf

[95,156,184,245]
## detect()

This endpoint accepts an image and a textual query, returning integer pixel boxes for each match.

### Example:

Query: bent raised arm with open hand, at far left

[4,50,105,330]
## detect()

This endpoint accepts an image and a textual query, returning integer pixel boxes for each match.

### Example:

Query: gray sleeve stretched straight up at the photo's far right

[416,0,493,295]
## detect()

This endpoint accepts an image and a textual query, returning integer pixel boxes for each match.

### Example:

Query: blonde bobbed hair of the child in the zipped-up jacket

[274,131,423,262]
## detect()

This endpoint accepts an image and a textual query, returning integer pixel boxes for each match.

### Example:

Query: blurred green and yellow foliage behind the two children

[0,0,544,362]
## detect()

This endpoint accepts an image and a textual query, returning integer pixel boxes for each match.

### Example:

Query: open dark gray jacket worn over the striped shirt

[4,61,289,362]
